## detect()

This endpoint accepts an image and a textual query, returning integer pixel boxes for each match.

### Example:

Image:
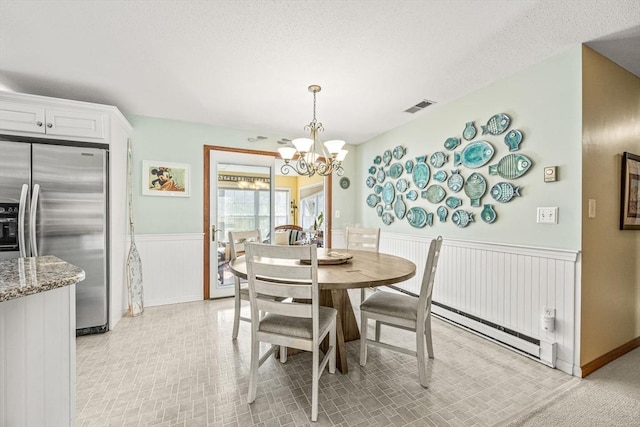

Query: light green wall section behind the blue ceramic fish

[355,46,582,250]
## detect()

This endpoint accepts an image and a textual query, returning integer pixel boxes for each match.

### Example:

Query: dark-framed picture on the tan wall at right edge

[620,152,640,230]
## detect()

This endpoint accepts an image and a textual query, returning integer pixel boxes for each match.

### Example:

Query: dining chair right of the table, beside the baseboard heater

[360,236,442,387]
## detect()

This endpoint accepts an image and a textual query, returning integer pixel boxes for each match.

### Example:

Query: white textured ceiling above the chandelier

[0,0,640,144]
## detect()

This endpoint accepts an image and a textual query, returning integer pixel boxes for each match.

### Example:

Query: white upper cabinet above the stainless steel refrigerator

[0,100,105,140]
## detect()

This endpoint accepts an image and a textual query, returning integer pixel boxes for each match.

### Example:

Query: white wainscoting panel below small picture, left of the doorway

[136,233,204,307]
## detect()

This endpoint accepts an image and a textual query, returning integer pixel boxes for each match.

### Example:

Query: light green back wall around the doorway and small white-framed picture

[127,115,356,234]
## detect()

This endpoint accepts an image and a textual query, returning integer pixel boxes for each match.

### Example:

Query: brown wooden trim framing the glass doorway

[202,145,333,300]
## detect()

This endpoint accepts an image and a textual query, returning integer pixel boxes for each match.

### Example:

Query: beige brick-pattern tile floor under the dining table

[76,291,578,427]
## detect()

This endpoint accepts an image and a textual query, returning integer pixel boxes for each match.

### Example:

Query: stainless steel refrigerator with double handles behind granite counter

[0,135,109,335]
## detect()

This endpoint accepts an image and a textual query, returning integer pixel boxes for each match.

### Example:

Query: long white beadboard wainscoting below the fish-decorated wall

[380,232,579,374]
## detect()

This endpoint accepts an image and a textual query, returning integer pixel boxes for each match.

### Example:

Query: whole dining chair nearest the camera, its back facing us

[246,243,337,421]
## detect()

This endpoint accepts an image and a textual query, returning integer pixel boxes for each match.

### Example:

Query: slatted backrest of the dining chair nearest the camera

[245,243,319,328]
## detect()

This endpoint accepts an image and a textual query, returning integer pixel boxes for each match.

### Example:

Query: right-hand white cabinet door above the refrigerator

[46,108,105,139]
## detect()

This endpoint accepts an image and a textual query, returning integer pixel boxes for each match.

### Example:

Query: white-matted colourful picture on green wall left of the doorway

[142,160,191,197]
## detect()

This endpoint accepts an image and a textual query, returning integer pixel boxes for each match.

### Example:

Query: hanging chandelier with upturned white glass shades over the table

[278,85,348,177]
